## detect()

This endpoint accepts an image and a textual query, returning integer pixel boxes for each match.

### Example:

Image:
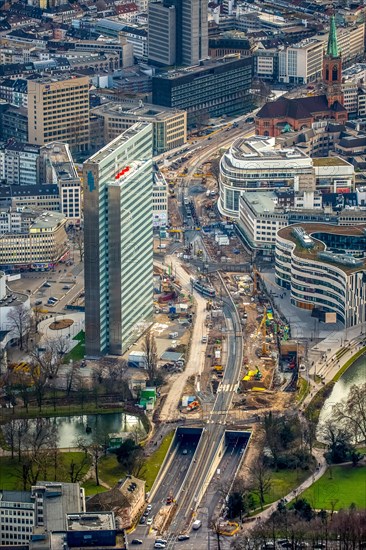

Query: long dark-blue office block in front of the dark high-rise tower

[152,55,252,126]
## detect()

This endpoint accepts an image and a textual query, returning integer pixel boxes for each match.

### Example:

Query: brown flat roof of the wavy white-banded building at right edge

[277,223,366,274]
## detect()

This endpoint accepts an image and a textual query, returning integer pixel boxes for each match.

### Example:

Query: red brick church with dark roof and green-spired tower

[255,17,348,137]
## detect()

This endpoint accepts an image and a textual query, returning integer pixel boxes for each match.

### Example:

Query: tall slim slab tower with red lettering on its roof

[83,122,153,357]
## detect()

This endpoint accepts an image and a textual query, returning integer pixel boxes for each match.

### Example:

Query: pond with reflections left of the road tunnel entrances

[18,412,146,449]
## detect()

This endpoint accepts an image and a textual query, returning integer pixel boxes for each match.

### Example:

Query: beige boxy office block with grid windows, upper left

[28,75,89,151]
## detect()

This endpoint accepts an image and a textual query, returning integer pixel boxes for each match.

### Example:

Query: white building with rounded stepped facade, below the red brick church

[218,136,315,218]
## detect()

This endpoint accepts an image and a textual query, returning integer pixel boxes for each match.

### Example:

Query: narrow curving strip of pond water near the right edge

[319,354,366,423]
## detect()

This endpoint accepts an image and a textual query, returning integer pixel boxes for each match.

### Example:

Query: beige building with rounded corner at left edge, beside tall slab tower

[0,211,68,269]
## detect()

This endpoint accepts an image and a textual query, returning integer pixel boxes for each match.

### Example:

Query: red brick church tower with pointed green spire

[323,15,343,107]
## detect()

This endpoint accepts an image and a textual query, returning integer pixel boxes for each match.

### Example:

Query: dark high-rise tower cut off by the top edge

[148,0,208,65]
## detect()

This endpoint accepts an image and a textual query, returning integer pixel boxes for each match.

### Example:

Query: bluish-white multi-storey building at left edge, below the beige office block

[0,141,39,186]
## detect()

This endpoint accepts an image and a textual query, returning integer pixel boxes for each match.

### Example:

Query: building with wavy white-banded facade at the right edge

[275,224,366,327]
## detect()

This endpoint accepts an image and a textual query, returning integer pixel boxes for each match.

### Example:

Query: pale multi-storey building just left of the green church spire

[278,38,324,84]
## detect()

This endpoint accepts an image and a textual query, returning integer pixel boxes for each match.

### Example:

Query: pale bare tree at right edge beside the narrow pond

[332,383,366,443]
